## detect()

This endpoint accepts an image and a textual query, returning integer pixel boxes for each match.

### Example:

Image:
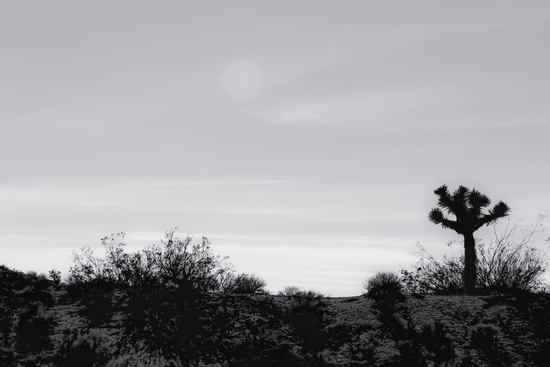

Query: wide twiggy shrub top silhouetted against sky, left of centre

[68,230,231,293]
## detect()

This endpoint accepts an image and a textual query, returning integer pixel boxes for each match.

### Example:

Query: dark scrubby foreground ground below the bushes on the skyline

[0,269,550,367]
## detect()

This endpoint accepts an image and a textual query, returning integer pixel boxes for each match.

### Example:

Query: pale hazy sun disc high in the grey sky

[223,59,264,101]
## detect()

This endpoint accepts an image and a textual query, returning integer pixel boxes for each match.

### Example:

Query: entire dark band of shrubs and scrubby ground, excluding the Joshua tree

[0,208,550,367]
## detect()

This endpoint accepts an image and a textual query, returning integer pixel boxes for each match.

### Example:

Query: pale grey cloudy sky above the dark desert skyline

[0,0,550,296]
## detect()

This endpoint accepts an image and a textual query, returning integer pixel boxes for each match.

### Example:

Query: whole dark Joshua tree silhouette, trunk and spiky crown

[428,185,510,292]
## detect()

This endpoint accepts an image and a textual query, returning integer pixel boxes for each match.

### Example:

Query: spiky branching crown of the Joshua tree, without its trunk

[428,185,510,234]
